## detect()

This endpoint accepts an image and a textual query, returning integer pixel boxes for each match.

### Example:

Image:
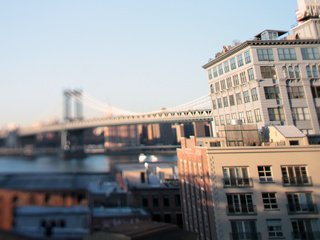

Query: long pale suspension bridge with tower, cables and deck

[19,90,212,136]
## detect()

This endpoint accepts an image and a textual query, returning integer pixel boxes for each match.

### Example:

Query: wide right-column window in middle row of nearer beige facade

[287,192,316,213]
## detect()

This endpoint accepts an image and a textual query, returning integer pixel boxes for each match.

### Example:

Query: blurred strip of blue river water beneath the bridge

[0,154,177,173]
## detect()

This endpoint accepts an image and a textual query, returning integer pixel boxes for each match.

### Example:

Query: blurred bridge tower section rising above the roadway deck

[63,89,83,122]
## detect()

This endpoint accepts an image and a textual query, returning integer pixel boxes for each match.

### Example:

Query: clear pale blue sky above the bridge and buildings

[0,0,297,128]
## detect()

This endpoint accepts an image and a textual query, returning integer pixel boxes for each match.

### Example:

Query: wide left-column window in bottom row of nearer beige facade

[230,220,259,240]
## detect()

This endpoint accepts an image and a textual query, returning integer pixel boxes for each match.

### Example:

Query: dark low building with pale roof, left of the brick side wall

[117,163,182,226]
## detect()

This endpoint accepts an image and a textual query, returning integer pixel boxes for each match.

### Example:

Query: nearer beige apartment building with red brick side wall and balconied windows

[178,126,320,240]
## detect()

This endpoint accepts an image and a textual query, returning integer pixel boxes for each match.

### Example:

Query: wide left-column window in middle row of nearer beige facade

[227,193,255,215]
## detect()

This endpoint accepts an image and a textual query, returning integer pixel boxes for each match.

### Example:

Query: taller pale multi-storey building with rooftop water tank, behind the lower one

[203,0,320,134]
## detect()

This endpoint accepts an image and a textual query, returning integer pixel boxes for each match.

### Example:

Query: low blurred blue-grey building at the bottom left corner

[13,206,90,240]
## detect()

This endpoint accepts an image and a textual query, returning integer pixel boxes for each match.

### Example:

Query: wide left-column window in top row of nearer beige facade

[223,167,252,187]
